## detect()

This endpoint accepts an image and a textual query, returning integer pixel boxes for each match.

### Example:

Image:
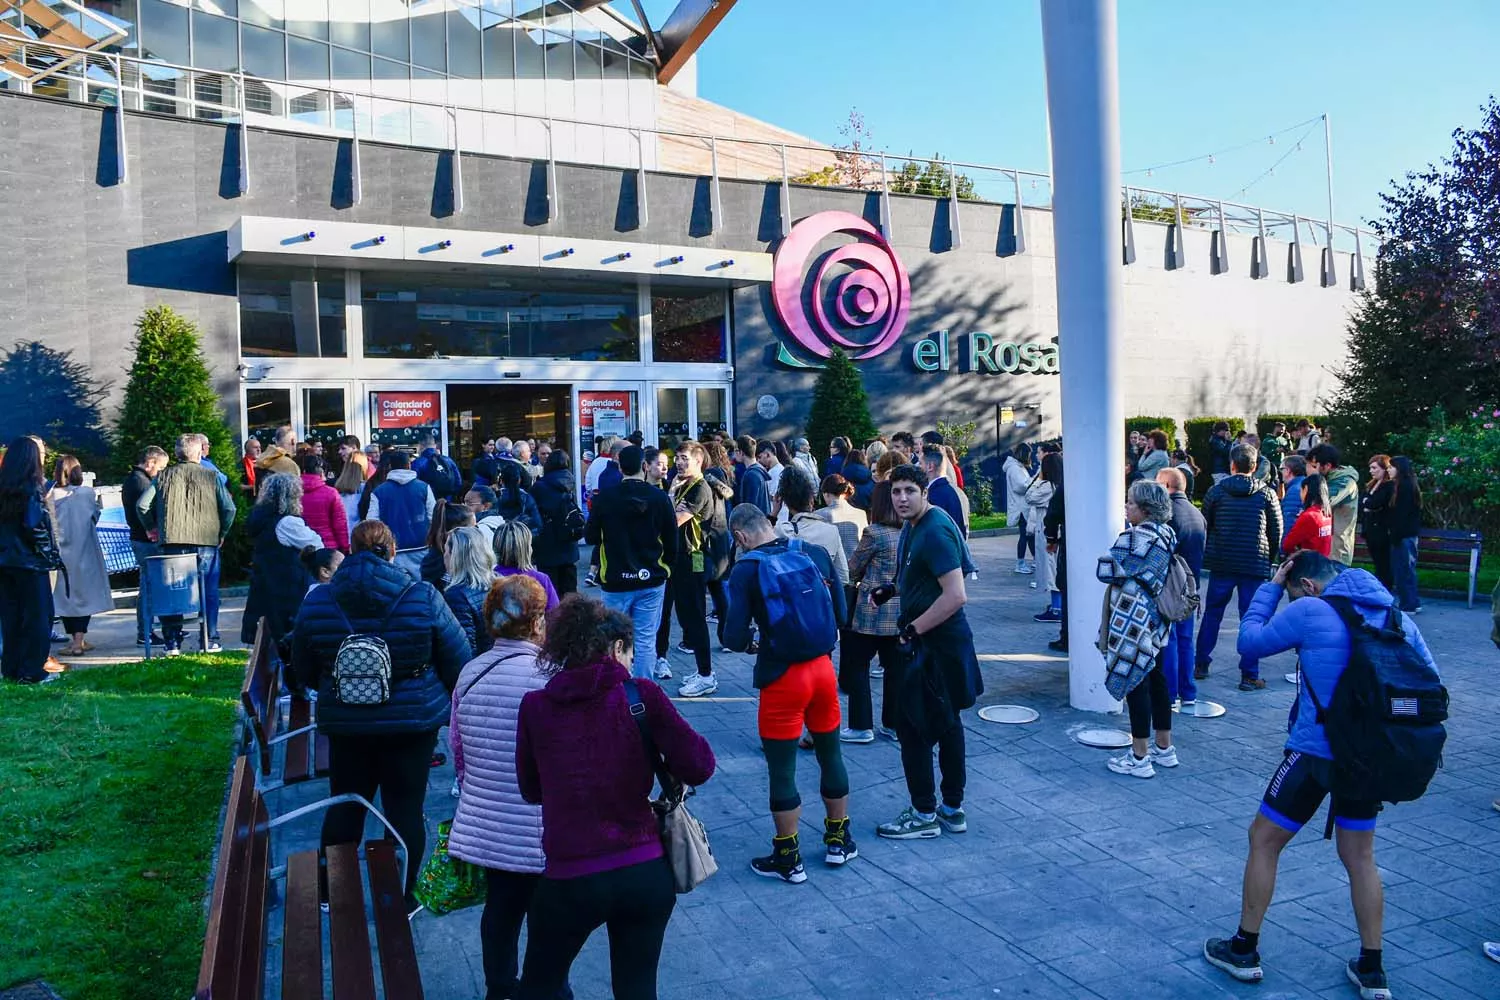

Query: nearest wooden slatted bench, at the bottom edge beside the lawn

[194,757,423,1000]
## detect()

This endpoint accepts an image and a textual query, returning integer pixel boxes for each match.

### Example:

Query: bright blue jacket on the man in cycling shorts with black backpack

[1239,570,1437,760]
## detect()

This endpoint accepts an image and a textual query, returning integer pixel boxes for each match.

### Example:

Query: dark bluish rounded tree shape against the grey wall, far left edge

[0,340,107,468]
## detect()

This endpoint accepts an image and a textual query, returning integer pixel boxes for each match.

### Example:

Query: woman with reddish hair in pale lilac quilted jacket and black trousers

[449,575,567,997]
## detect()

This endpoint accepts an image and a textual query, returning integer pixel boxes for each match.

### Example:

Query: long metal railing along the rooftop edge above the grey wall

[0,42,1376,255]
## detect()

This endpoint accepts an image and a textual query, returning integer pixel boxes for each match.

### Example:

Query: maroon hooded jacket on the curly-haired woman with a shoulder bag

[516,660,716,879]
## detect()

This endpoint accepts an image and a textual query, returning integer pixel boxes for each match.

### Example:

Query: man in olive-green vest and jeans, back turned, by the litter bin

[153,433,234,657]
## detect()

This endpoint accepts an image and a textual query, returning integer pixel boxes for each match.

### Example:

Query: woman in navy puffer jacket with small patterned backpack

[293,520,470,913]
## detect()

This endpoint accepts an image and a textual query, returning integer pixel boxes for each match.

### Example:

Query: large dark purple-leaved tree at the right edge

[1325,97,1500,454]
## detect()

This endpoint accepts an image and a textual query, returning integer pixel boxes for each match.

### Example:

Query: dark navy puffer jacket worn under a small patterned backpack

[291,552,470,736]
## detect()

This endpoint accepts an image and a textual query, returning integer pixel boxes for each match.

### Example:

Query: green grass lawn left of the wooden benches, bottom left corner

[0,654,245,1000]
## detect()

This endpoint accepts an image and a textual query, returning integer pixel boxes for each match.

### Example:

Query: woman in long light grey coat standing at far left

[48,454,114,657]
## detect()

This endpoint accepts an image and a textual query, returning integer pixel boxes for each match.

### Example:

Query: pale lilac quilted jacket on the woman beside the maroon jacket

[449,639,548,874]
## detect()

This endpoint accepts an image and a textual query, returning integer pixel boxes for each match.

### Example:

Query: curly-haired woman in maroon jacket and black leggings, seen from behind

[516,594,714,1000]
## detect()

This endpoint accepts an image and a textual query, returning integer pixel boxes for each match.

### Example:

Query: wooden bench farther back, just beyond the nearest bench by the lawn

[240,618,329,792]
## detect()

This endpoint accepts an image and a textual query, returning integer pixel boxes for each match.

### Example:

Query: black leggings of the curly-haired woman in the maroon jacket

[516,858,677,1000]
